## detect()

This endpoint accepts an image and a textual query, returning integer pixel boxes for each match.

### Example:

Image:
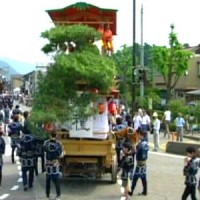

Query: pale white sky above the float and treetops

[0,0,200,69]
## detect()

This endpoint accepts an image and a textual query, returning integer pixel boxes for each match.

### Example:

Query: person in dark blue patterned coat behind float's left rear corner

[44,132,62,200]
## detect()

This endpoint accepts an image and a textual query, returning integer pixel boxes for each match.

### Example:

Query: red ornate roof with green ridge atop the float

[46,2,117,35]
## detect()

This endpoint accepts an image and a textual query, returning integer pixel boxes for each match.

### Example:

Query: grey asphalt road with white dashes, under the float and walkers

[0,103,200,200]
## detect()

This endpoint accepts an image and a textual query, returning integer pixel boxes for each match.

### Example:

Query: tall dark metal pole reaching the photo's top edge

[132,0,136,116]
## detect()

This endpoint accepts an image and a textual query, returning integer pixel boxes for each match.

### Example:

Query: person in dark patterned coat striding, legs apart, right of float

[128,130,149,196]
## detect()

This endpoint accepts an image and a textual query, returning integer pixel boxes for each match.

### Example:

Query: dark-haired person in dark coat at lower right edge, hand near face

[182,146,199,200]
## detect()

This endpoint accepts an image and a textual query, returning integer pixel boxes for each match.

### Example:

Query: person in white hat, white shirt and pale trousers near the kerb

[152,112,160,151]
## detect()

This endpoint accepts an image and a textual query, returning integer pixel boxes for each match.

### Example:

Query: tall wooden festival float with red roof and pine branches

[31,2,138,183]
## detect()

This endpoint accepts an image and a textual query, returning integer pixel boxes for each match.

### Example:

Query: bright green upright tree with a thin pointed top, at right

[152,25,193,101]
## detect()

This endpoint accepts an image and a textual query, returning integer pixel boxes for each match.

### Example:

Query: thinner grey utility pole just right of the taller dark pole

[140,5,145,98]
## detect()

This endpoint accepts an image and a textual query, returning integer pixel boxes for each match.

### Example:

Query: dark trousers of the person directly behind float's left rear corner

[46,174,61,197]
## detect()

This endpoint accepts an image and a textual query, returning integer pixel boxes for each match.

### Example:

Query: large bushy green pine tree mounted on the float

[31,25,116,122]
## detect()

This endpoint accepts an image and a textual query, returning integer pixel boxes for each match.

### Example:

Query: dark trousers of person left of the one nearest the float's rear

[22,167,34,187]
